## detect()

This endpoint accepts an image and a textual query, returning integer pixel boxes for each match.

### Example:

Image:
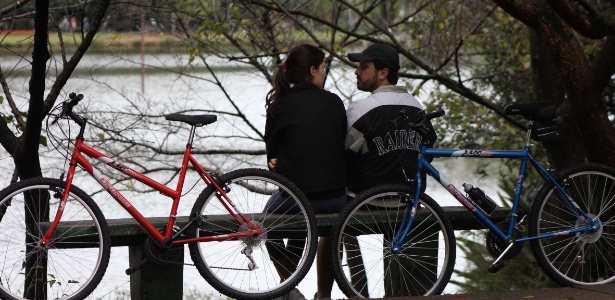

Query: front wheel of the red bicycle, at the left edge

[0,178,111,299]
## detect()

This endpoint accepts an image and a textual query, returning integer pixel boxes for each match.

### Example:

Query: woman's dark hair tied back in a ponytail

[265,44,325,112]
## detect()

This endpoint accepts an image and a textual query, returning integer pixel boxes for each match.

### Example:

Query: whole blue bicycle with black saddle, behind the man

[331,103,615,298]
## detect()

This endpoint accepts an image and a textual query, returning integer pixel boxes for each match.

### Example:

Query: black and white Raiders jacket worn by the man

[345,85,436,193]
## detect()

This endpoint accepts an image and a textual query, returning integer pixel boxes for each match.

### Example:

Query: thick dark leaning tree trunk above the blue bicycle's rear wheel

[493,0,615,166]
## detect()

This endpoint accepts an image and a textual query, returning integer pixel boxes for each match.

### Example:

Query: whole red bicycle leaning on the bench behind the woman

[0,93,317,299]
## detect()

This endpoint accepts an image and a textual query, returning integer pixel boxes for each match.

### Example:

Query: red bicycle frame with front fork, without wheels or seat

[41,138,262,245]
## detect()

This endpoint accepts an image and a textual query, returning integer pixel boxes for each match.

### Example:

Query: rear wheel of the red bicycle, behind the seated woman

[189,169,317,299]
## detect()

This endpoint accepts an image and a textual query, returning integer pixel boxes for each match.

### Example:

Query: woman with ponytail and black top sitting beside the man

[265,44,346,299]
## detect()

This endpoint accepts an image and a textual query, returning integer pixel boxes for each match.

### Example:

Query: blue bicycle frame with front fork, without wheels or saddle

[392,126,600,251]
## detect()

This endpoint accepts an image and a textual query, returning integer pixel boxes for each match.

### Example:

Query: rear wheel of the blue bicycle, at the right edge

[530,164,615,286]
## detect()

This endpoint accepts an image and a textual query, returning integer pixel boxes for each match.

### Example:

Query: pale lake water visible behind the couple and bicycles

[0,55,506,299]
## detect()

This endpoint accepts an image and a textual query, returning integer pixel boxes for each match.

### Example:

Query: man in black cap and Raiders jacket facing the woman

[346,44,437,196]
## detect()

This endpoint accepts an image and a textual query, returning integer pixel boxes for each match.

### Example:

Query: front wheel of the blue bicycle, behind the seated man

[330,185,456,298]
